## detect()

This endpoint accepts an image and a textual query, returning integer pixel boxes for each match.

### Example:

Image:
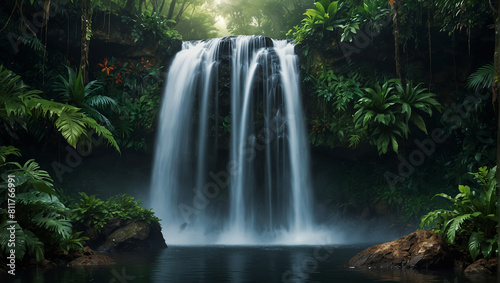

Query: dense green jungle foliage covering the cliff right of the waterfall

[287,0,497,229]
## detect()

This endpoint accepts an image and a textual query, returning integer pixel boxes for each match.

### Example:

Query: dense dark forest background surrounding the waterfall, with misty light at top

[0,0,500,266]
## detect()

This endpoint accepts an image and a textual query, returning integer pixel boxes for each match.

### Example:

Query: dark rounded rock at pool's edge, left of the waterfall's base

[97,221,167,251]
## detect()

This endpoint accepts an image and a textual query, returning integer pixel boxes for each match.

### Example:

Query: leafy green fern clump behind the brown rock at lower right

[420,167,499,260]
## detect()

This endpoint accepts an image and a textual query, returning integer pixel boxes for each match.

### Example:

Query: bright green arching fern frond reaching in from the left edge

[0,66,120,151]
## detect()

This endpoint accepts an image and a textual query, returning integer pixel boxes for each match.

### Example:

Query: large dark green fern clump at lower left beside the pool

[0,150,84,262]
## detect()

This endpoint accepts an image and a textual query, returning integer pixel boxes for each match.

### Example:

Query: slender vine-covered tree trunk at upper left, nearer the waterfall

[80,0,92,84]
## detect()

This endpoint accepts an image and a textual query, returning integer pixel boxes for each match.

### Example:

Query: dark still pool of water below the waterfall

[4,245,498,283]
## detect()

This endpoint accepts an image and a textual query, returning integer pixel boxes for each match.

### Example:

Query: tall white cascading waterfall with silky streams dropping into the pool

[151,36,328,244]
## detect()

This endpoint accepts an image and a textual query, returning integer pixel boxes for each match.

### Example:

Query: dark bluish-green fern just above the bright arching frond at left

[55,66,118,131]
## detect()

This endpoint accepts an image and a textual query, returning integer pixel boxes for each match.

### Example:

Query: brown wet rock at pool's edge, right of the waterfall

[347,230,460,269]
